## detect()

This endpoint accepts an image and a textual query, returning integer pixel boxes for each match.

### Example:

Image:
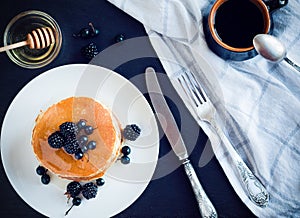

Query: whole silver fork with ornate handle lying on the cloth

[177,72,269,207]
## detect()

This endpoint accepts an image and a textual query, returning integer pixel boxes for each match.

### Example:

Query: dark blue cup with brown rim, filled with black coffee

[203,0,288,61]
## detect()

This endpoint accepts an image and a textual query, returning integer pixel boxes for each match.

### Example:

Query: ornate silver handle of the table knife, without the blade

[182,159,218,218]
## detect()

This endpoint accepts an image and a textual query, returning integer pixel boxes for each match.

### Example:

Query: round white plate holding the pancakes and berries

[1,64,159,218]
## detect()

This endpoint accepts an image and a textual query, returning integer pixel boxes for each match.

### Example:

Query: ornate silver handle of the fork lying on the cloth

[214,123,269,207]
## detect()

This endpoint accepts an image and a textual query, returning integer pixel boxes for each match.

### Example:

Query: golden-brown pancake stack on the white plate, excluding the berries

[32,97,122,181]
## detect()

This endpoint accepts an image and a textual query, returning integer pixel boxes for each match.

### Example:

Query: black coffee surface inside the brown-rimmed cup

[215,0,264,48]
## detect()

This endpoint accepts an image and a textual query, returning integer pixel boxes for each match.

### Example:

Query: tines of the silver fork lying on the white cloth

[178,71,207,107]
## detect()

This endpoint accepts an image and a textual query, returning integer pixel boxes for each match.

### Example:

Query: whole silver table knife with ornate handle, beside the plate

[145,67,218,218]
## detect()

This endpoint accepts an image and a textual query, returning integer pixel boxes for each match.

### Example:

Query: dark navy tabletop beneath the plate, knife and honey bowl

[0,0,253,217]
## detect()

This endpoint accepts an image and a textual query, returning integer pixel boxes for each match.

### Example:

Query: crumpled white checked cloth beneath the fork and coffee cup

[108,0,300,217]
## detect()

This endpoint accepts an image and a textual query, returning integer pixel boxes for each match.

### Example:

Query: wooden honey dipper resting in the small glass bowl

[0,27,55,52]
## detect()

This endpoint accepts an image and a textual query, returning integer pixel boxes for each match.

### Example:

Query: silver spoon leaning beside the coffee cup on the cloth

[253,34,300,72]
